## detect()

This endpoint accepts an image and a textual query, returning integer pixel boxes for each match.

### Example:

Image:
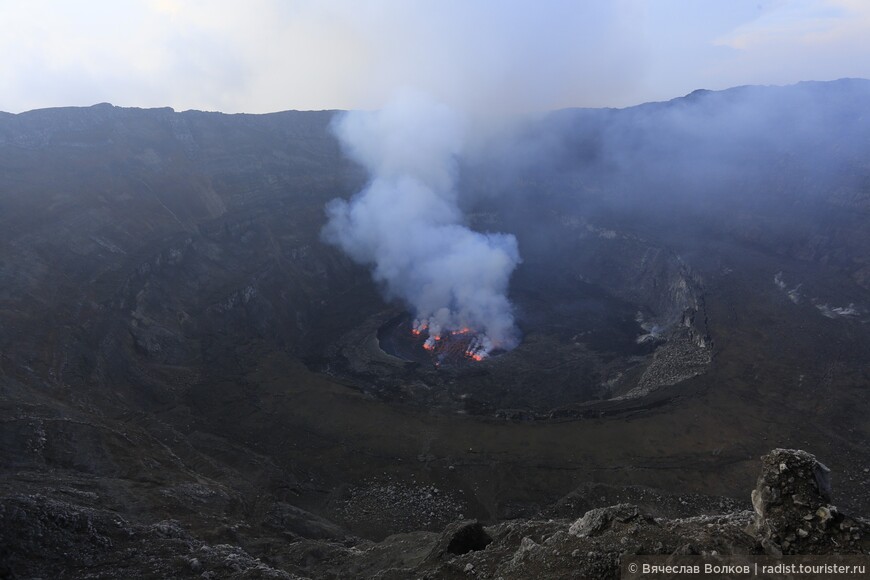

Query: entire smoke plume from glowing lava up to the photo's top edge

[323,0,652,358]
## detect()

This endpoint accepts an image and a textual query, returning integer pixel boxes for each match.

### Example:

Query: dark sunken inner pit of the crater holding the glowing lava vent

[324,215,711,419]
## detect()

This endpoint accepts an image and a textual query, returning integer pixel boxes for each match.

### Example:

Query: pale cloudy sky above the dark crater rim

[0,0,870,113]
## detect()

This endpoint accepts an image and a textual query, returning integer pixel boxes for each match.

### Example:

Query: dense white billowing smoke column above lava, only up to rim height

[323,92,520,355]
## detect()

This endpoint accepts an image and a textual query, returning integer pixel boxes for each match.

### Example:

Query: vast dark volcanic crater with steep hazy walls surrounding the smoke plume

[0,80,870,578]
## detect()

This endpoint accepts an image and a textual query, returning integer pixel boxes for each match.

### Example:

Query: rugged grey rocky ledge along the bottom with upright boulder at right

[0,449,870,579]
